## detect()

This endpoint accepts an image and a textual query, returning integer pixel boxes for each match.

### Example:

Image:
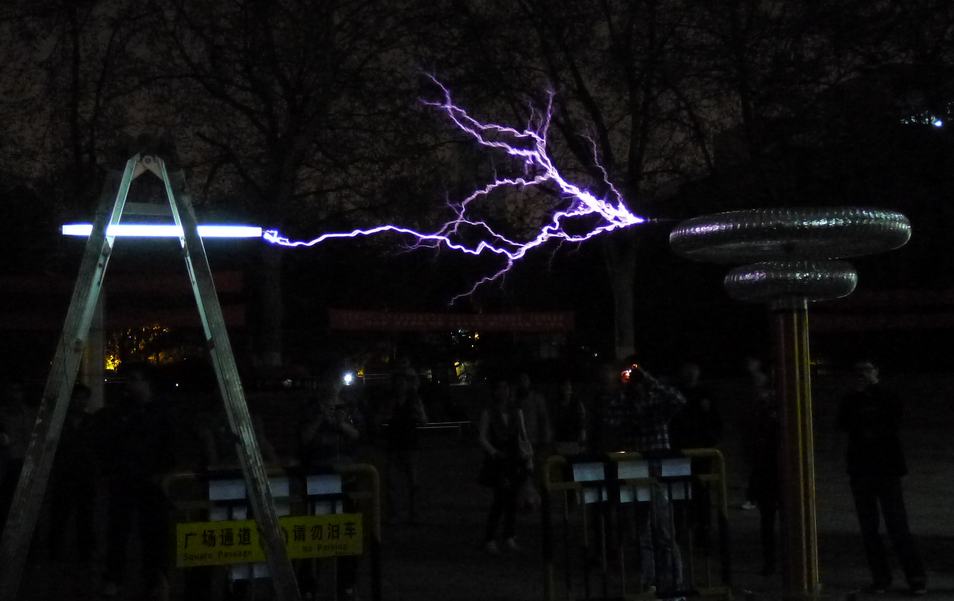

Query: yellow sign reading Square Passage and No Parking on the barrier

[176,513,362,568]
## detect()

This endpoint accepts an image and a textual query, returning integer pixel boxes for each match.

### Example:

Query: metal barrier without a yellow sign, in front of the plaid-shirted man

[541,449,731,601]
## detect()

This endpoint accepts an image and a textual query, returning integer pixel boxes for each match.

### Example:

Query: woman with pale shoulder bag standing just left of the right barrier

[478,380,533,555]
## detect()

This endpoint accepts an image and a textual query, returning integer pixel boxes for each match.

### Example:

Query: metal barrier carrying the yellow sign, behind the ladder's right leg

[162,463,382,601]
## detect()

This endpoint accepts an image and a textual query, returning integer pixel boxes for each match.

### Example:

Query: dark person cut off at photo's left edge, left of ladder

[0,380,36,525]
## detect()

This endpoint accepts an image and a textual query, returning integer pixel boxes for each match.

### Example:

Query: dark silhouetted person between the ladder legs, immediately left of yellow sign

[97,363,175,599]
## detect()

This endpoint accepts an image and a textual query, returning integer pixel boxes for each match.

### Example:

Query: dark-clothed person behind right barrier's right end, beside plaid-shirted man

[669,363,722,547]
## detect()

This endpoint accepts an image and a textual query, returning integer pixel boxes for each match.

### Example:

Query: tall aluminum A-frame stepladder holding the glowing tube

[0,142,301,601]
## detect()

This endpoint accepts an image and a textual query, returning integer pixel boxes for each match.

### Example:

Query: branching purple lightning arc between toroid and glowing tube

[263,78,645,300]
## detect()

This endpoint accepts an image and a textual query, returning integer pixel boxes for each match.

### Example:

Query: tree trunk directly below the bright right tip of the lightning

[603,228,636,359]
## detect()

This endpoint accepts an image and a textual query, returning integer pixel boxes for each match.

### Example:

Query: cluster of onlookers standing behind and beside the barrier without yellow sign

[468,361,708,591]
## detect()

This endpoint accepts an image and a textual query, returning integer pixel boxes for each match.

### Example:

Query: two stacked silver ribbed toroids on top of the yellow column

[669,207,911,306]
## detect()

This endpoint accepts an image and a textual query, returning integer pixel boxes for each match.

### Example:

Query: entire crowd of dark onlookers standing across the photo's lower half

[0,359,926,599]
